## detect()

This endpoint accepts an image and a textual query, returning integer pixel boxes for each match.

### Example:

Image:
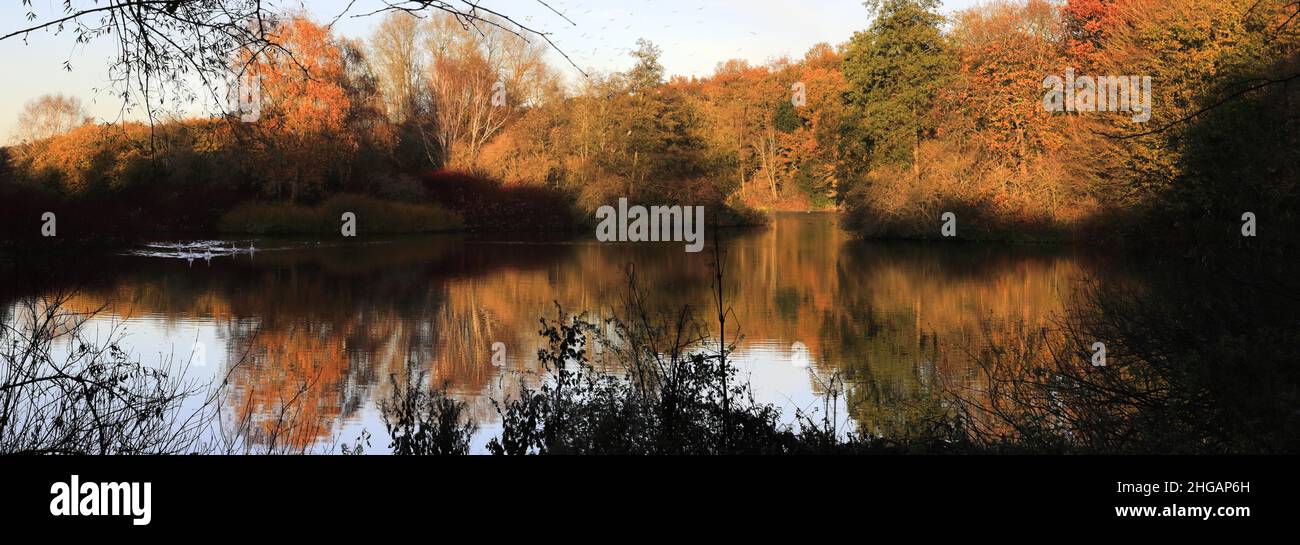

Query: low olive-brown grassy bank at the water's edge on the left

[217,195,464,235]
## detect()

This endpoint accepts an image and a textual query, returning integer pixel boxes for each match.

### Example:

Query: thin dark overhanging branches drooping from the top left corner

[0,0,574,120]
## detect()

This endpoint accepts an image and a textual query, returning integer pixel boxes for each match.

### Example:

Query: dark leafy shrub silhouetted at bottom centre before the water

[488,274,876,455]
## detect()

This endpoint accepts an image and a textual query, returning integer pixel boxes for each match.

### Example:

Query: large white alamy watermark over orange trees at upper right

[1043,68,1151,124]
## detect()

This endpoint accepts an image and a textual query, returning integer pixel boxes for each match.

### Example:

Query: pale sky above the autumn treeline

[0,0,976,142]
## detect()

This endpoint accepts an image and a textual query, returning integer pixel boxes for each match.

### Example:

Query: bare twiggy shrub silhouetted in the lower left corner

[0,294,211,455]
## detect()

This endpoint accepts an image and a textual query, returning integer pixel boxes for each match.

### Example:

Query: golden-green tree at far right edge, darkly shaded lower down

[1092,0,1300,222]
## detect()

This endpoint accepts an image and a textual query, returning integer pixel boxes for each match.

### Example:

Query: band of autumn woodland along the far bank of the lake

[0,0,1300,241]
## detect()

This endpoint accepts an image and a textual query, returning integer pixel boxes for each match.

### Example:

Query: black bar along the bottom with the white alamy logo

[0,457,1279,538]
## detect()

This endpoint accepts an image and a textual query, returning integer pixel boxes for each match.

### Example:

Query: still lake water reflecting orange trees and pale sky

[10,213,1100,451]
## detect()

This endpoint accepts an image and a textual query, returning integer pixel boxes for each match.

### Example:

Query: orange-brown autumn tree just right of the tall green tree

[937,0,1106,221]
